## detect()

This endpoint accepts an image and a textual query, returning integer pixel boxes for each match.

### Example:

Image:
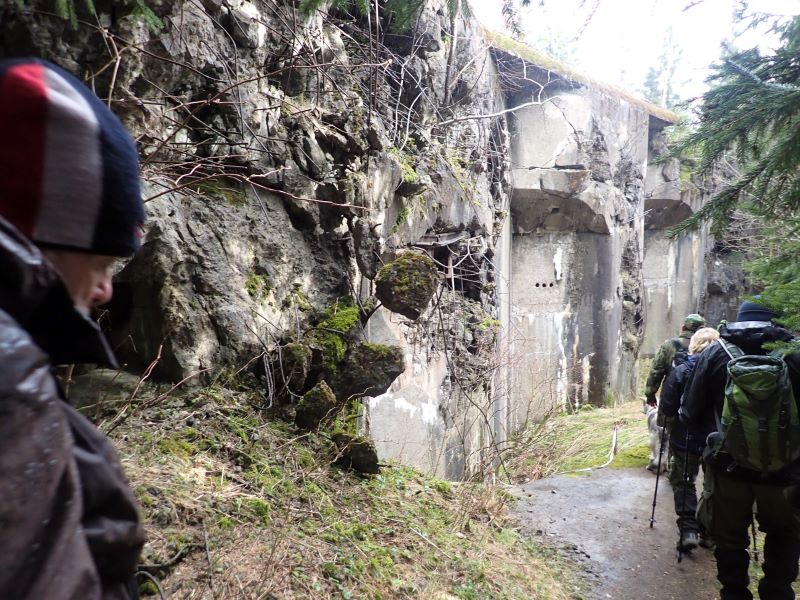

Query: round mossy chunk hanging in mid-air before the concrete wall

[375,251,439,320]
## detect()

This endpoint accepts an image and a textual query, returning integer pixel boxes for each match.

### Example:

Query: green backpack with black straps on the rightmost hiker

[716,340,800,473]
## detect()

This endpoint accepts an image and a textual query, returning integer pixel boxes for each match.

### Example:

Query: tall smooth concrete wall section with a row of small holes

[509,88,649,412]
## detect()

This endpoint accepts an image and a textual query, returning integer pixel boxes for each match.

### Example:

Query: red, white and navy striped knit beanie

[0,59,144,256]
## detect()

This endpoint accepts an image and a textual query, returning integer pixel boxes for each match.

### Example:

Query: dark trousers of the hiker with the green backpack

[697,467,800,600]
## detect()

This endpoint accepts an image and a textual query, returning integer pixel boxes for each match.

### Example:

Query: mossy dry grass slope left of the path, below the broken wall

[101,388,582,600]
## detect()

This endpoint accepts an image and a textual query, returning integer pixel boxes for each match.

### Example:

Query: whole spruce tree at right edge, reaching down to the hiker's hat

[672,17,800,329]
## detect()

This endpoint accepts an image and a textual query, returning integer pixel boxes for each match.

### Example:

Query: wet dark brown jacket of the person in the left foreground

[0,219,144,600]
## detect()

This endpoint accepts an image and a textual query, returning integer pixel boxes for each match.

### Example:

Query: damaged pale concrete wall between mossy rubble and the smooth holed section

[363,16,510,479]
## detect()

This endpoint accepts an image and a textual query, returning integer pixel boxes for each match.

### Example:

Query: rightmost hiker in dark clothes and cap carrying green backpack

[679,302,800,600]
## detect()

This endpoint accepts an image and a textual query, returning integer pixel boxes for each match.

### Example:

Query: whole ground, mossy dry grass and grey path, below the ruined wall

[75,368,776,600]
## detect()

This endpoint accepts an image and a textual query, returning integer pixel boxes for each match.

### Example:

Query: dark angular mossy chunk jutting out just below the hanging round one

[333,342,405,398]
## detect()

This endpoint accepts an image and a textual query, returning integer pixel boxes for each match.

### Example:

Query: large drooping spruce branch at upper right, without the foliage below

[671,17,800,235]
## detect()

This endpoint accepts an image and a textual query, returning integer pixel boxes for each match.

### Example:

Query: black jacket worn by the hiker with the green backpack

[680,321,800,483]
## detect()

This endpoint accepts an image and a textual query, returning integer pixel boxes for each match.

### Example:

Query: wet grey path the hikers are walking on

[512,469,718,600]
